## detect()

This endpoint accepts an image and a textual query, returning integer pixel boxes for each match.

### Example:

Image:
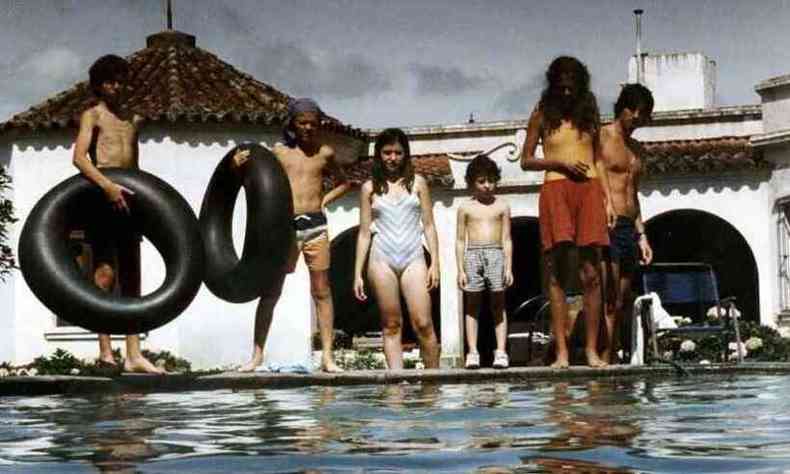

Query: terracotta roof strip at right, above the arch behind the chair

[641,137,772,175]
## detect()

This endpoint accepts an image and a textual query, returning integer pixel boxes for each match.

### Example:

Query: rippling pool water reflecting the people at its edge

[0,375,790,473]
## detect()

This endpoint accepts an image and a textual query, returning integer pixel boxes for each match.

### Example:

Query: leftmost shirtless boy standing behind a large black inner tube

[73,55,164,374]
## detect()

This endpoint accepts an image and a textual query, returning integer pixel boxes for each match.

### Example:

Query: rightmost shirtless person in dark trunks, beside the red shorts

[601,84,653,363]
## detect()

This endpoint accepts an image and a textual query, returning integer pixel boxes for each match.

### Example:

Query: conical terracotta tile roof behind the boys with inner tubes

[0,31,366,139]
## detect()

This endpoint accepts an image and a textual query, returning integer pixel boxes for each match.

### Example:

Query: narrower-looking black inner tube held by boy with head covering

[200,144,295,303]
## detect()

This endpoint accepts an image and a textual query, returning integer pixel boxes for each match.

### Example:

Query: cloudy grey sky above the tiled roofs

[0,0,790,128]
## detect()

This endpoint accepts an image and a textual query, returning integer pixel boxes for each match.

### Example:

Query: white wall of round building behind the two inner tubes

[0,125,336,368]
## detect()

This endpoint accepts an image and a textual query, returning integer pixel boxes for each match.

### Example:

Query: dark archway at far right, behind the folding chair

[645,209,760,321]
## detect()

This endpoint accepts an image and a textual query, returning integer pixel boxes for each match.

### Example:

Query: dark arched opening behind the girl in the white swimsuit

[329,226,441,343]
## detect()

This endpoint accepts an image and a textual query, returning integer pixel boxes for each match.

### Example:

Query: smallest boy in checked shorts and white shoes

[455,155,513,369]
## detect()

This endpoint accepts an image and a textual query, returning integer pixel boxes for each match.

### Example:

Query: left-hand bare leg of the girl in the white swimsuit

[368,258,403,370]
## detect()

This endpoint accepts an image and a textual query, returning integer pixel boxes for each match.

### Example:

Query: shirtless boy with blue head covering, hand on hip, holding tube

[233,99,350,372]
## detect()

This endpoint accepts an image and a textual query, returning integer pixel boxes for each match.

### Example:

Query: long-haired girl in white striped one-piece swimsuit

[354,128,439,369]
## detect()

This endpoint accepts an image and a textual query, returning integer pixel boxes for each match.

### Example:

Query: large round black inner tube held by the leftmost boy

[19,168,204,334]
